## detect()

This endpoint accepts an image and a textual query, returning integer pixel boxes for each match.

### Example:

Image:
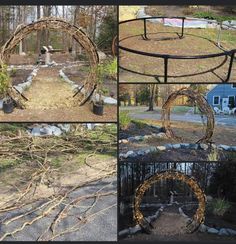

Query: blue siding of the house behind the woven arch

[206,84,236,109]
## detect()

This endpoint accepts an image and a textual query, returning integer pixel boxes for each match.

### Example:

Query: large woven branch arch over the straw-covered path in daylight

[0,17,99,105]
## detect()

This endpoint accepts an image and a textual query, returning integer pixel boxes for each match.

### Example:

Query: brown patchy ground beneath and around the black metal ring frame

[119,11,236,83]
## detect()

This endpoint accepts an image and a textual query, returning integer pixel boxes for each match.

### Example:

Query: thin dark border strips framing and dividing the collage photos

[0,0,236,244]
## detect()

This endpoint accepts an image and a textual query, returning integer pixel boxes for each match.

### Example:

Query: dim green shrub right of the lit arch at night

[208,198,231,217]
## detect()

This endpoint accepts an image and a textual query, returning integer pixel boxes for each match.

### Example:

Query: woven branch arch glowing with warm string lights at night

[133,170,206,233]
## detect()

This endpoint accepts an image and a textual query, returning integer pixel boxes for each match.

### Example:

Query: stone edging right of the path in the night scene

[179,205,236,236]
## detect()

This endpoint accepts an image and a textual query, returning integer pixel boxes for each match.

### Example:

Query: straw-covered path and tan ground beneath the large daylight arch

[0,54,117,122]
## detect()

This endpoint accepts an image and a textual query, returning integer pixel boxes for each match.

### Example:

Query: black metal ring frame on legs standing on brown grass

[118,16,236,83]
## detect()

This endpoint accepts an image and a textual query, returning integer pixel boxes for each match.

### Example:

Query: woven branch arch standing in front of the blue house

[161,87,215,143]
